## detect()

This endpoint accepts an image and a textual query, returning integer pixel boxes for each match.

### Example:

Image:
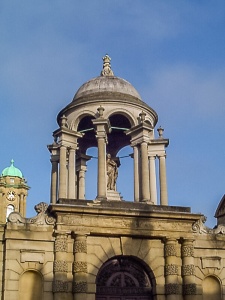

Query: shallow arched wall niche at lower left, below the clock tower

[19,270,43,300]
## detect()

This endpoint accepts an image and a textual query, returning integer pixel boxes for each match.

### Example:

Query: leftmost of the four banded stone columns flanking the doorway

[53,232,68,300]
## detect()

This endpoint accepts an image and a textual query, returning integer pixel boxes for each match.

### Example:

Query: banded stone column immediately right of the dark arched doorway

[164,238,180,300]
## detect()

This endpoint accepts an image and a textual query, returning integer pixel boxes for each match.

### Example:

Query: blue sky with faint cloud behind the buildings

[0,0,225,227]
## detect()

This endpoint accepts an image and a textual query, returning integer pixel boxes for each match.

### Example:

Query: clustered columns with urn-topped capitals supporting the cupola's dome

[48,111,168,205]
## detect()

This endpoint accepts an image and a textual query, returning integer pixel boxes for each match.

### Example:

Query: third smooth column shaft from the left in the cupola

[68,148,76,199]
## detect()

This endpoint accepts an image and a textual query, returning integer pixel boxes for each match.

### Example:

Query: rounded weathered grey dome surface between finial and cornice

[73,76,141,101]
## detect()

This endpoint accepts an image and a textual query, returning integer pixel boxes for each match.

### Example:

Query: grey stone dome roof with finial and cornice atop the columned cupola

[57,54,158,126]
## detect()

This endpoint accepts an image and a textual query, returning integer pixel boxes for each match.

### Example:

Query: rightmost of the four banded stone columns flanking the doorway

[181,239,196,300]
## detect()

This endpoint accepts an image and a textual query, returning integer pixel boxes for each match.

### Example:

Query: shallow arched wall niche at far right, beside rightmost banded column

[202,275,222,300]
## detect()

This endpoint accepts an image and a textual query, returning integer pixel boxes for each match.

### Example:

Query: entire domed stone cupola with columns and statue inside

[48,55,169,205]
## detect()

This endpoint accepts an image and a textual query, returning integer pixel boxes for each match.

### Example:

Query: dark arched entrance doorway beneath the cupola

[96,256,153,300]
